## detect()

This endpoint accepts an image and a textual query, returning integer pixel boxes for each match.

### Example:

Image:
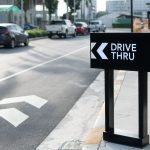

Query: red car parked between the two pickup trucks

[74,22,89,35]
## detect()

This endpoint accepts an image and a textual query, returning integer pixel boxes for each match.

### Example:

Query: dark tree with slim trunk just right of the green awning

[15,0,30,23]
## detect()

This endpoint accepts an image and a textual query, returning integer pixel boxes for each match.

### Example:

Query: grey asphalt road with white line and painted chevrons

[0,36,100,150]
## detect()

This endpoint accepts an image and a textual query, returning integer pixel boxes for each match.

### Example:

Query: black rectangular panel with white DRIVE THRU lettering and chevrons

[90,33,150,71]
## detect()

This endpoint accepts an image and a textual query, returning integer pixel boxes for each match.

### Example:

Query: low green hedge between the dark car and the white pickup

[26,29,47,38]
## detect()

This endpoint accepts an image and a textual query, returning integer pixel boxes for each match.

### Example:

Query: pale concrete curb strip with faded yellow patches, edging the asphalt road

[36,71,125,150]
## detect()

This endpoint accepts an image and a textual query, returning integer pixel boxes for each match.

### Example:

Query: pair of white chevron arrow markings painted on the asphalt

[0,95,48,127]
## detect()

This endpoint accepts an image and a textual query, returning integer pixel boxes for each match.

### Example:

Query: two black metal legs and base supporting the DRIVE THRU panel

[103,69,149,147]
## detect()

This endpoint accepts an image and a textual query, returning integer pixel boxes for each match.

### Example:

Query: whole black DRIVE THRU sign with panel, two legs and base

[90,33,150,147]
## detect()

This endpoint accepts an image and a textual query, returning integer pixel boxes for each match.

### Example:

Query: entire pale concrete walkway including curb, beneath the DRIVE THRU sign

[37,71,150,150]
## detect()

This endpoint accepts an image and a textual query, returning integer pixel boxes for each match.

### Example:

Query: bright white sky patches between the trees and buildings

[58,0,106,16]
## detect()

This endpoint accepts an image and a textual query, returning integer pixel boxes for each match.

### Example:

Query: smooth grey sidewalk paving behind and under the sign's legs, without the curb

[92,71,150,150]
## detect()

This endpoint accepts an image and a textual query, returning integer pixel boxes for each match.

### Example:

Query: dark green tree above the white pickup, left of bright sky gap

[45,0,58,21]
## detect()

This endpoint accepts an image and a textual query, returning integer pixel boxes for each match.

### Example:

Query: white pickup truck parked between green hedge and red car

[46,19,76,38]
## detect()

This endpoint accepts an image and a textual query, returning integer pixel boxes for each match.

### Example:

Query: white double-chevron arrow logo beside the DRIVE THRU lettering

[91,43,108,59]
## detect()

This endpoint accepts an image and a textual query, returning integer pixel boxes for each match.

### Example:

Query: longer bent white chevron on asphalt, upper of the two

[0,95,48,109]
